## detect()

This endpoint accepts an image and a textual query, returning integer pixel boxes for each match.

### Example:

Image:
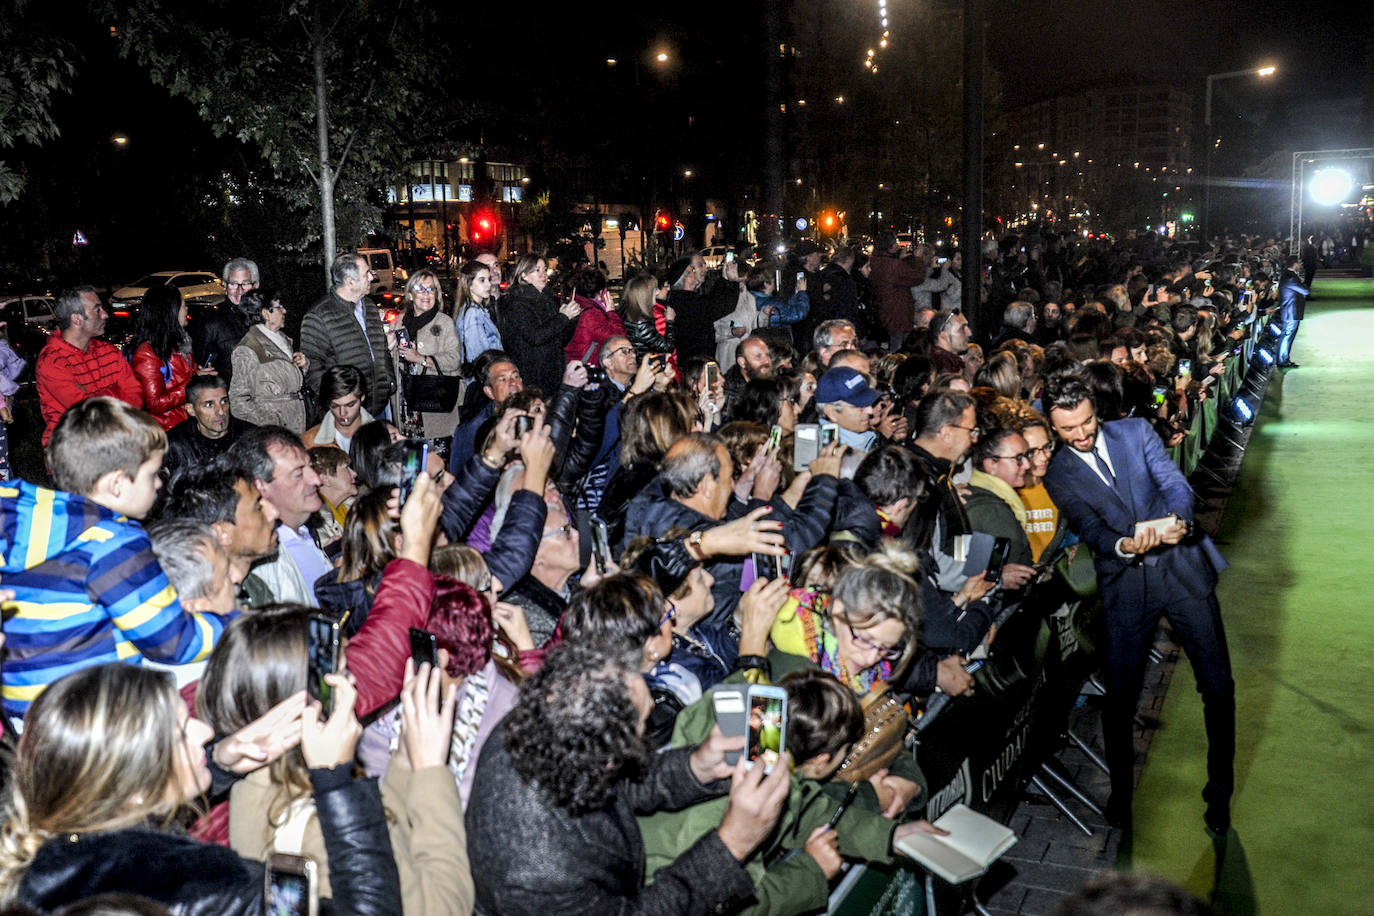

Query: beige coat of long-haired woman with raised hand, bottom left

[229,758,475,916]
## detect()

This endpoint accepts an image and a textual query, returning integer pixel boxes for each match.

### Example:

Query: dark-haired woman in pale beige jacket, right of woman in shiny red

[229,290,311,434]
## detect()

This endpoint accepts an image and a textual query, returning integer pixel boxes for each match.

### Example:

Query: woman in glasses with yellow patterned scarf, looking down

[769,541,925,817]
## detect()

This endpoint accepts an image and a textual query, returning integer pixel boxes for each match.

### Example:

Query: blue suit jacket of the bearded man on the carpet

[1044,419,1226,610]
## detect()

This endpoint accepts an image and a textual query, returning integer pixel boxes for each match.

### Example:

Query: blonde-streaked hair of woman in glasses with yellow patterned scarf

[831,540,922,672]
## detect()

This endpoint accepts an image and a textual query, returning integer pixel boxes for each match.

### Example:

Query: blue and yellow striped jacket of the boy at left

[0,481,229,717]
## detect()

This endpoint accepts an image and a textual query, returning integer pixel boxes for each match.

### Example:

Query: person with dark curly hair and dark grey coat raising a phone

[467,644,790,916]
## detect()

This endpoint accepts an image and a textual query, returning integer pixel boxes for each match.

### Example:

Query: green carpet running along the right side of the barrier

[1123,277,1374,915]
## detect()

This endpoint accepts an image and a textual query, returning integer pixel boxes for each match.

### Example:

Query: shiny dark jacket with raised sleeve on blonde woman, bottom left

[18,770,401,916]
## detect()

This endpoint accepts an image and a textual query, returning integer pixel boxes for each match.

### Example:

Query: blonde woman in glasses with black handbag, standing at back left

[392,271,463,444]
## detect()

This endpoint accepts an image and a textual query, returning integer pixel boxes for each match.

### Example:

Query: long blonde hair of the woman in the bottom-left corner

[0,663,181,901]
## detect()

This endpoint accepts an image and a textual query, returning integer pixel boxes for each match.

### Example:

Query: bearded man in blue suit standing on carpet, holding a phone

[1044,375,1235,835]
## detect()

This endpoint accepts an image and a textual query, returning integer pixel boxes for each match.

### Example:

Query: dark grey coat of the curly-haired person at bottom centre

[466,725,754,916]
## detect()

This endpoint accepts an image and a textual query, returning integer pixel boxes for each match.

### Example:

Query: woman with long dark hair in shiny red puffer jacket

[131,286,203,430]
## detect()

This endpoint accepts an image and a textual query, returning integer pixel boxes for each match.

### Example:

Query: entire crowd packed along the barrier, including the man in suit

[0,227,1305,916]
